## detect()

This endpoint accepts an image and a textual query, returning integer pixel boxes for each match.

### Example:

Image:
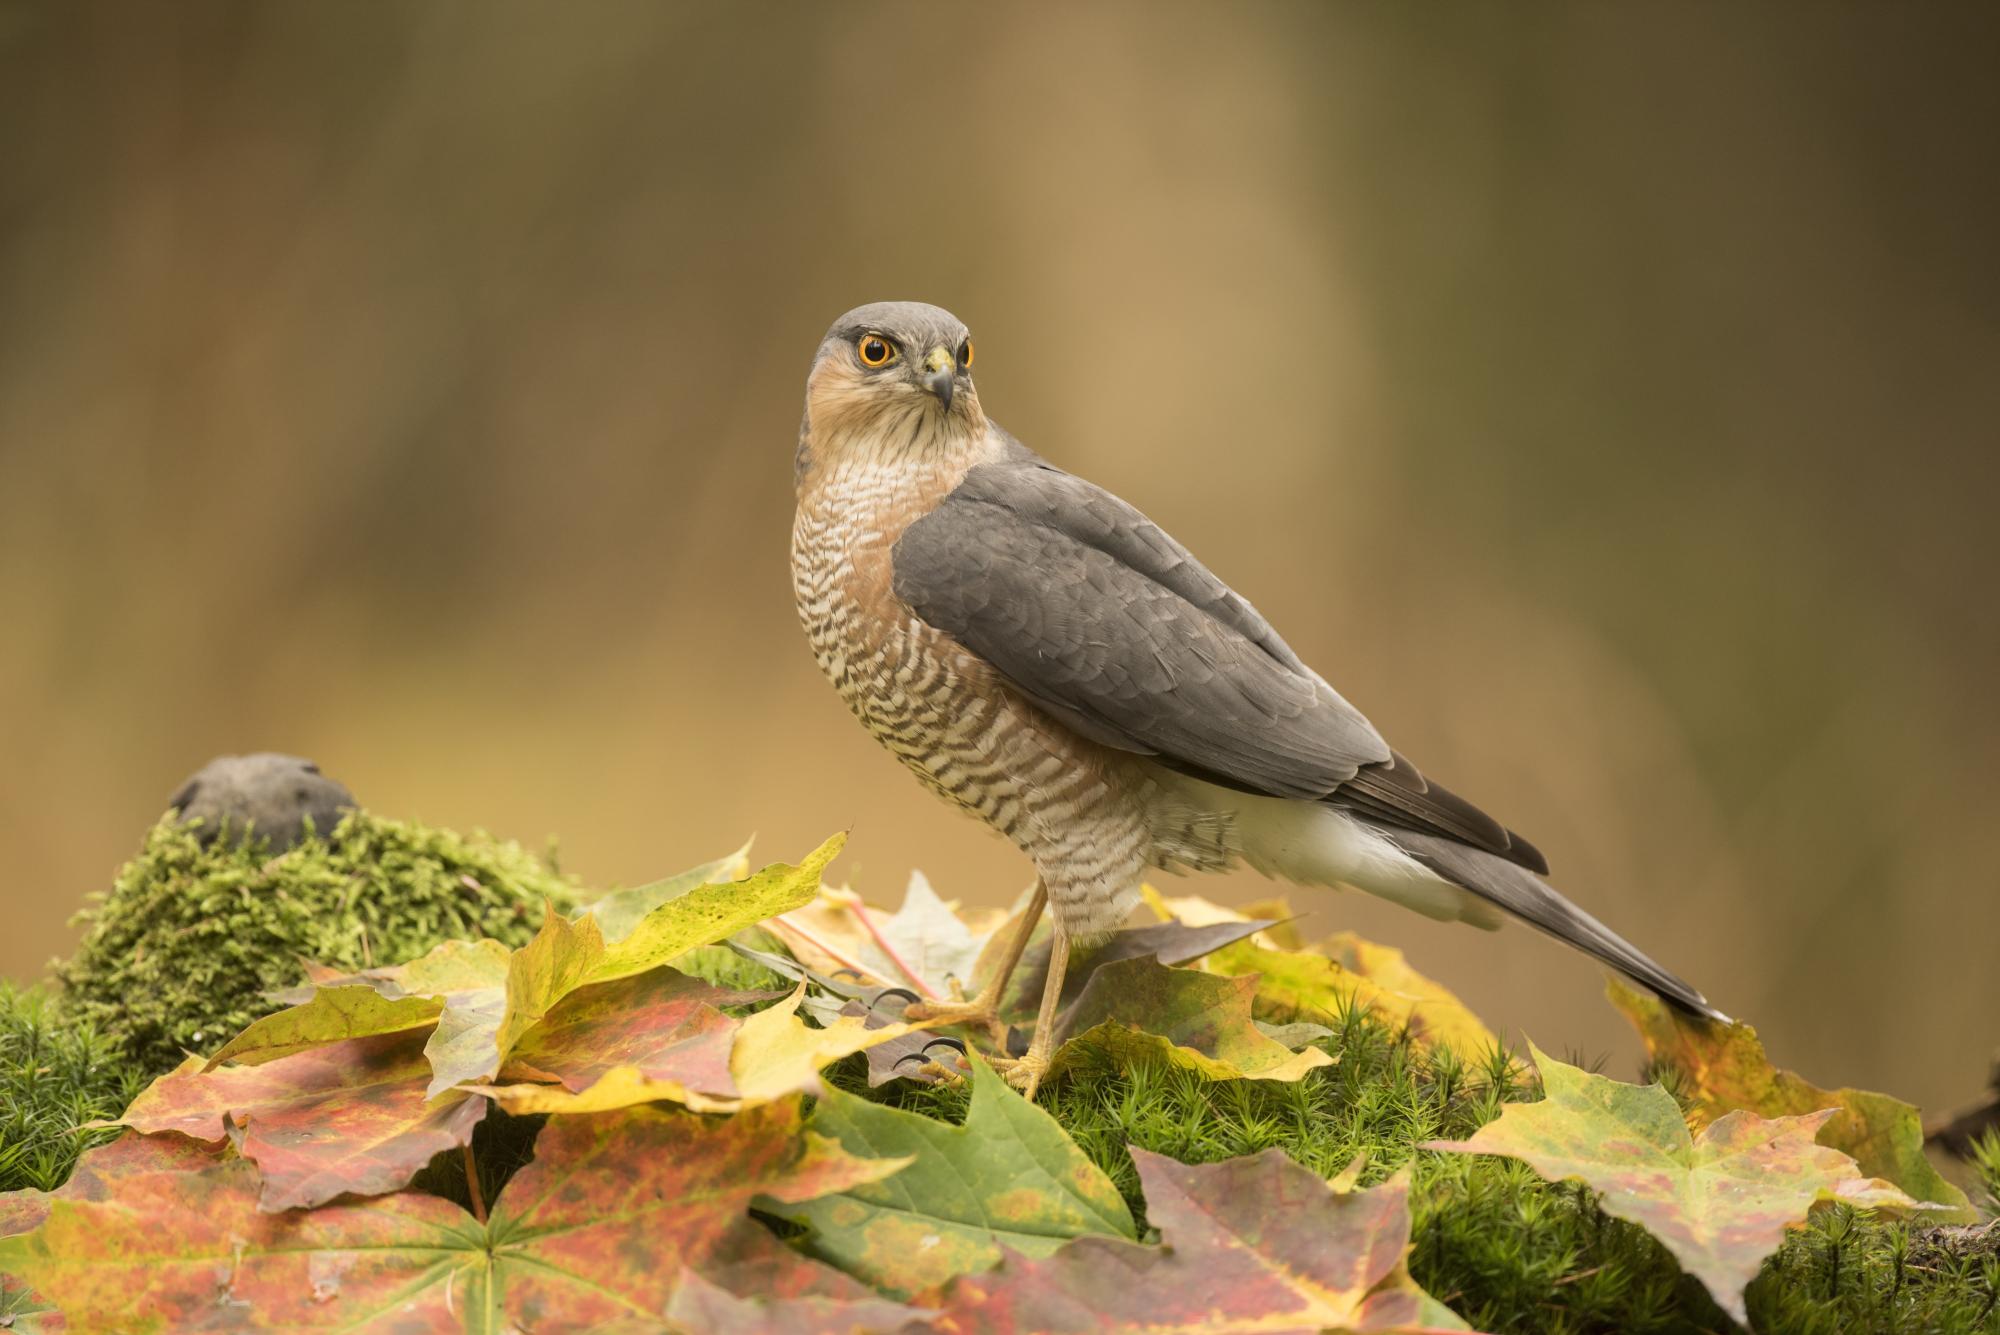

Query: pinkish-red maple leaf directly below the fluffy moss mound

[118,1029,488,1211]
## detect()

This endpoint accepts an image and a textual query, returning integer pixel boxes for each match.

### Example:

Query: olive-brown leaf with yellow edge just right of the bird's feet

[1052,957,1334,1081]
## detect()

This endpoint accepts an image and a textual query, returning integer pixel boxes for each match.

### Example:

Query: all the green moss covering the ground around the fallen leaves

[0,813,2000,1335]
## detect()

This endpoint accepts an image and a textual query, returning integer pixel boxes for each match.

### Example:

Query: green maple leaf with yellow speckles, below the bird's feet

[774,1057,1134,1297]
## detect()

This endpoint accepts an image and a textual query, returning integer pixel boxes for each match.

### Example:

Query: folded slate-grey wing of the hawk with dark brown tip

[894,453,1548,871]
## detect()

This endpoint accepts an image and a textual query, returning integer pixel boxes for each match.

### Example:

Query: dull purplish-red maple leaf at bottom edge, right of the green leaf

[936,1147,1466,1335]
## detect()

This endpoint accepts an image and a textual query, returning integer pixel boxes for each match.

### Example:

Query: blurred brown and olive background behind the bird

[0,0,2000,1105]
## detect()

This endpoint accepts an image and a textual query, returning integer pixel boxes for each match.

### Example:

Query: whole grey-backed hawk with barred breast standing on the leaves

[792,302,1720,1097]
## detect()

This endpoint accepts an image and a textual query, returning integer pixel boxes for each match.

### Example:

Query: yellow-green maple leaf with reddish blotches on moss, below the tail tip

[1424,1043,1862,1323]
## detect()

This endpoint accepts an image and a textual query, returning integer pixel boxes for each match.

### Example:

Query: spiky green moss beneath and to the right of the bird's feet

[836,1011,2000,1335]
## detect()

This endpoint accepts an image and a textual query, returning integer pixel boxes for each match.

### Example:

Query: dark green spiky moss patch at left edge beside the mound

[0,983,146,1191]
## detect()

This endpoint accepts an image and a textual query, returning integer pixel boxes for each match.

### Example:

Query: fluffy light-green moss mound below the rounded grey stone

[54,811,582,1075]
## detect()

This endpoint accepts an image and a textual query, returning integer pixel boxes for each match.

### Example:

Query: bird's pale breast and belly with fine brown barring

[792,453,1160,935]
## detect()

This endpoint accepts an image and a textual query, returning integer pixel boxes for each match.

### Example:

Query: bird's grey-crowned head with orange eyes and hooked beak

[798,302,986,474]
